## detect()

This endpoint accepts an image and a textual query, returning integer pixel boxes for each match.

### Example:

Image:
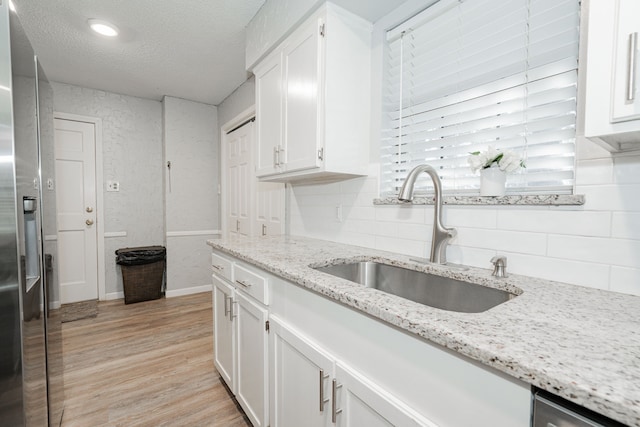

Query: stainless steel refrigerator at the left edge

[0,0,64,426]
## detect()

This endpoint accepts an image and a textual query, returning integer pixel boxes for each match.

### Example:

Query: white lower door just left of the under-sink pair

[235,291,269,427]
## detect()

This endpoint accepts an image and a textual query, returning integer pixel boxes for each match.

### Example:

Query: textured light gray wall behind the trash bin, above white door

[52,83,164,298]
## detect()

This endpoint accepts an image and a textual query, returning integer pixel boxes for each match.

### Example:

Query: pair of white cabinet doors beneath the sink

[270,316,435,427]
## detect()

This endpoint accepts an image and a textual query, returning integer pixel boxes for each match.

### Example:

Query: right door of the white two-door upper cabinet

[283,16,322,172]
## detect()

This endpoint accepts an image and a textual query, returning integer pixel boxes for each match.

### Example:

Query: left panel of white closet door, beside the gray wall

[225,122,255,236]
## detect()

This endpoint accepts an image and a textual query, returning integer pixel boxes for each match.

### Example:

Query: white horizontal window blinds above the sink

[381,0,580,196]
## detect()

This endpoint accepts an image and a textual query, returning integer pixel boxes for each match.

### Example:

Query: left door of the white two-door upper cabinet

[255,54,283,177]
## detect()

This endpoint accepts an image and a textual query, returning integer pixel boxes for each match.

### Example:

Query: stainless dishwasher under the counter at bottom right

[531,390,624,427]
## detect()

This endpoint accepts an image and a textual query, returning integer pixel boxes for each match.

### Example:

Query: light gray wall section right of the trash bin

[163,97,220,296]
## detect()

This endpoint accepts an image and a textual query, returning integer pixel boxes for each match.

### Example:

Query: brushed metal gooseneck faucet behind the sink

[398,165,457,264]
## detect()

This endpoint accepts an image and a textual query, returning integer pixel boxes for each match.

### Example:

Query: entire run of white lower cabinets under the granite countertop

[212,251,531,427]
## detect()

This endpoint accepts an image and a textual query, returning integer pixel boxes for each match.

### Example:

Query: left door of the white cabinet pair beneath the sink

[269,316,333,427]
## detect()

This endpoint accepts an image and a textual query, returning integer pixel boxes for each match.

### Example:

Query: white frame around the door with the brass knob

[53,111,107,301]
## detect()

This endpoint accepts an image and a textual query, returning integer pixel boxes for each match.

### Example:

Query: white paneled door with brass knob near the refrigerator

[55,119,98,304]
